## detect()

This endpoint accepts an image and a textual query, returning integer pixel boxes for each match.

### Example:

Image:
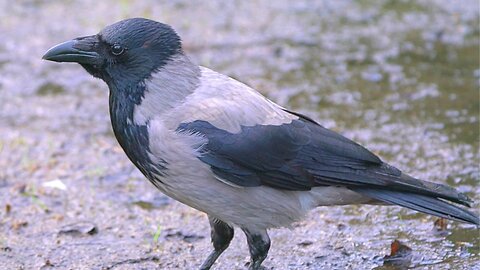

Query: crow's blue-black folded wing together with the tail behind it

[178,114,478,223]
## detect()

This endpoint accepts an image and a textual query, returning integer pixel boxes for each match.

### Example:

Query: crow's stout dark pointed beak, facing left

[42,36,100,64]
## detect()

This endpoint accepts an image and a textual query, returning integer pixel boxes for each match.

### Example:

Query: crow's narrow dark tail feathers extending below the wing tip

[352,188,480,225]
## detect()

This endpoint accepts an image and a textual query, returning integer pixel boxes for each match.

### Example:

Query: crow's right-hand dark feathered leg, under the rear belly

[243,229,270,270]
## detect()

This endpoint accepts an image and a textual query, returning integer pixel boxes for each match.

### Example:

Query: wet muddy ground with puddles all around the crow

[0,0,480,269]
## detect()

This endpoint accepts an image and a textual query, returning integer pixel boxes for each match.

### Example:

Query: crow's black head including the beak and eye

[43,18,182,87]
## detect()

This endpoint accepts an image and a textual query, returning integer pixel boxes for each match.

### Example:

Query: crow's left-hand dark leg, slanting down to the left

[200,216,233,270]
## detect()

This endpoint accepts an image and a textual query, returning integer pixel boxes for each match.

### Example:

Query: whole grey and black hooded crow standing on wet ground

[43,18,479,269]
